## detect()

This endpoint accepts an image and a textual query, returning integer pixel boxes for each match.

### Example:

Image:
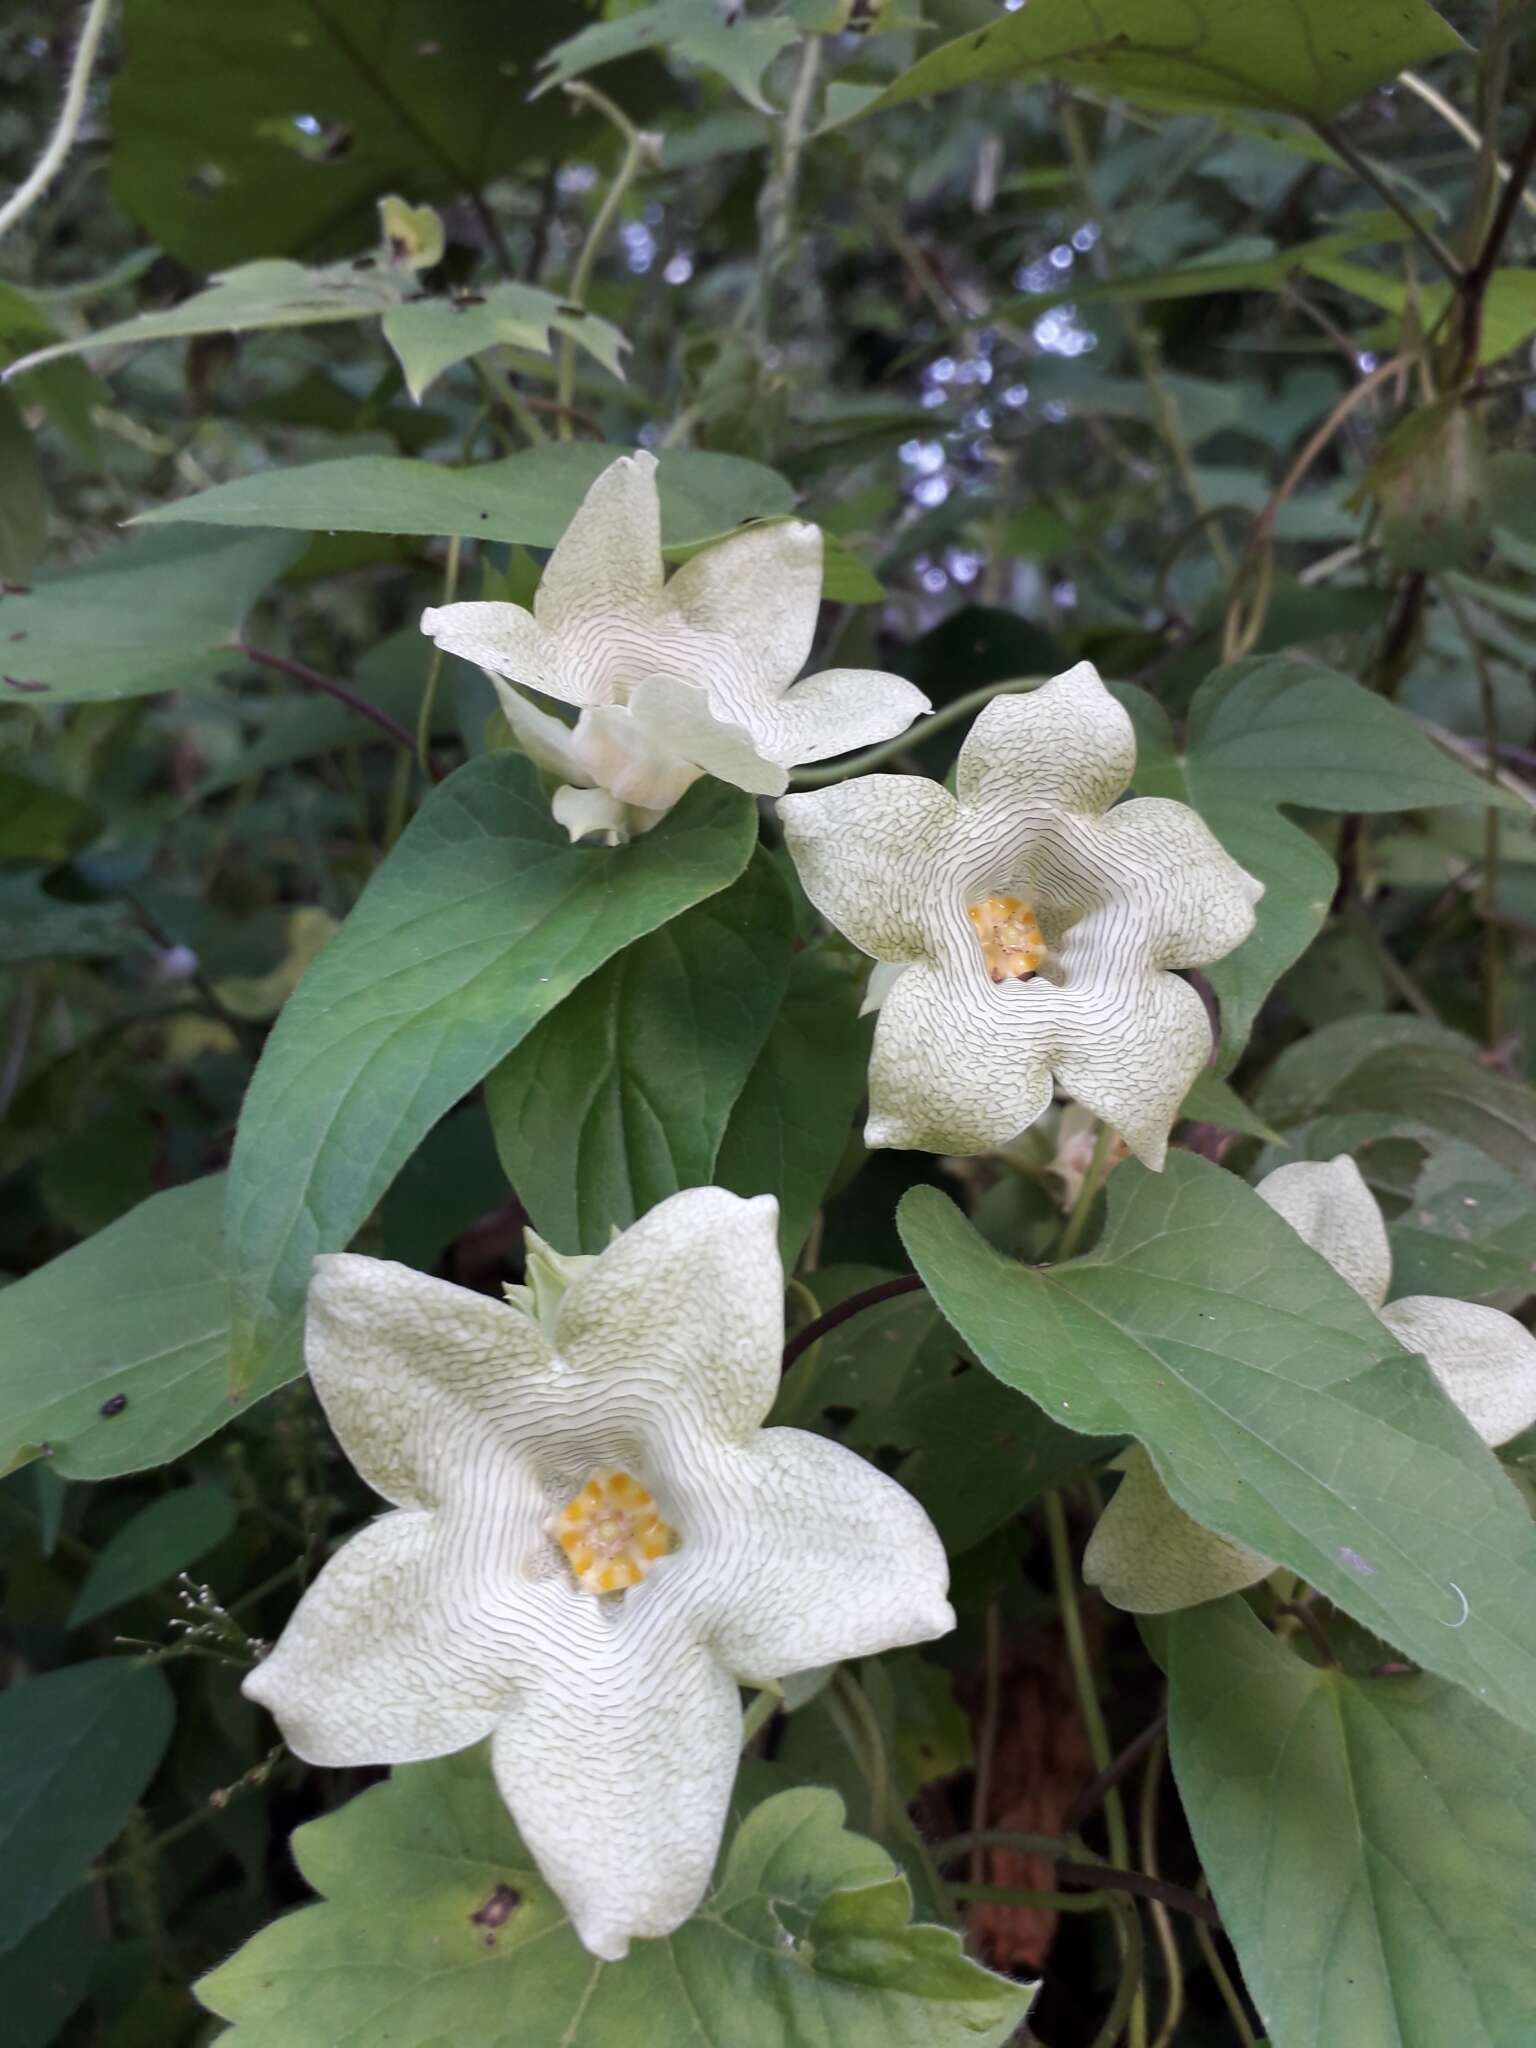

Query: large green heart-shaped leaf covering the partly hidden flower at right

[897,1153,1536,1729]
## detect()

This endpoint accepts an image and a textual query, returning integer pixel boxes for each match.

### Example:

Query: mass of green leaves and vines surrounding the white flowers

[0,0,1536,2048]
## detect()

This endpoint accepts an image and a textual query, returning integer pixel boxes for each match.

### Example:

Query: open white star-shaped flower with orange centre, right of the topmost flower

[778,662,1264,1167]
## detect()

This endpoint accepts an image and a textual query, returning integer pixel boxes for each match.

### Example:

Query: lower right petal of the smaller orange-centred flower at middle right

[1055,958,1210,1174]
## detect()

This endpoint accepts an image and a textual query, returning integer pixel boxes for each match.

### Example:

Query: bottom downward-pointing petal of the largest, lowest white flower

[492,1585,741,1962]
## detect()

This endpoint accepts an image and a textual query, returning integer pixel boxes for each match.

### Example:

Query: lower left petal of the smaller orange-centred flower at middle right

[868,958,1059,1153]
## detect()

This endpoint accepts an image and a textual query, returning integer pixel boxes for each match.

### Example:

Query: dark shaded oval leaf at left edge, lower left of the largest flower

[0,1657,176,1948]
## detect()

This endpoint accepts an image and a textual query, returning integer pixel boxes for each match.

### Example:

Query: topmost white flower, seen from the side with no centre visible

[422,453,930,838]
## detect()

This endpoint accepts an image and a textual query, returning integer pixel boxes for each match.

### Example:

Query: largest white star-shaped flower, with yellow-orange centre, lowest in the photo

[246,1188,954,1960]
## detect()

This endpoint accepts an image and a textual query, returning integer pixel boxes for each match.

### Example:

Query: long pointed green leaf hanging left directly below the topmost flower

[227,754,756,1384]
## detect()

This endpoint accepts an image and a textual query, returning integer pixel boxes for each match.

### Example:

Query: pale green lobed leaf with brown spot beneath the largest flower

[197,1749,1030,2048]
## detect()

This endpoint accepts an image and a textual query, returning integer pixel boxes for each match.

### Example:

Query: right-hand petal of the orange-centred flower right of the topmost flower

[1094,797,1264,967]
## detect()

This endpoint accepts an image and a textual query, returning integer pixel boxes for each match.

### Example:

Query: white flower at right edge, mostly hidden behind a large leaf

[1083,1153,1536,1614]
